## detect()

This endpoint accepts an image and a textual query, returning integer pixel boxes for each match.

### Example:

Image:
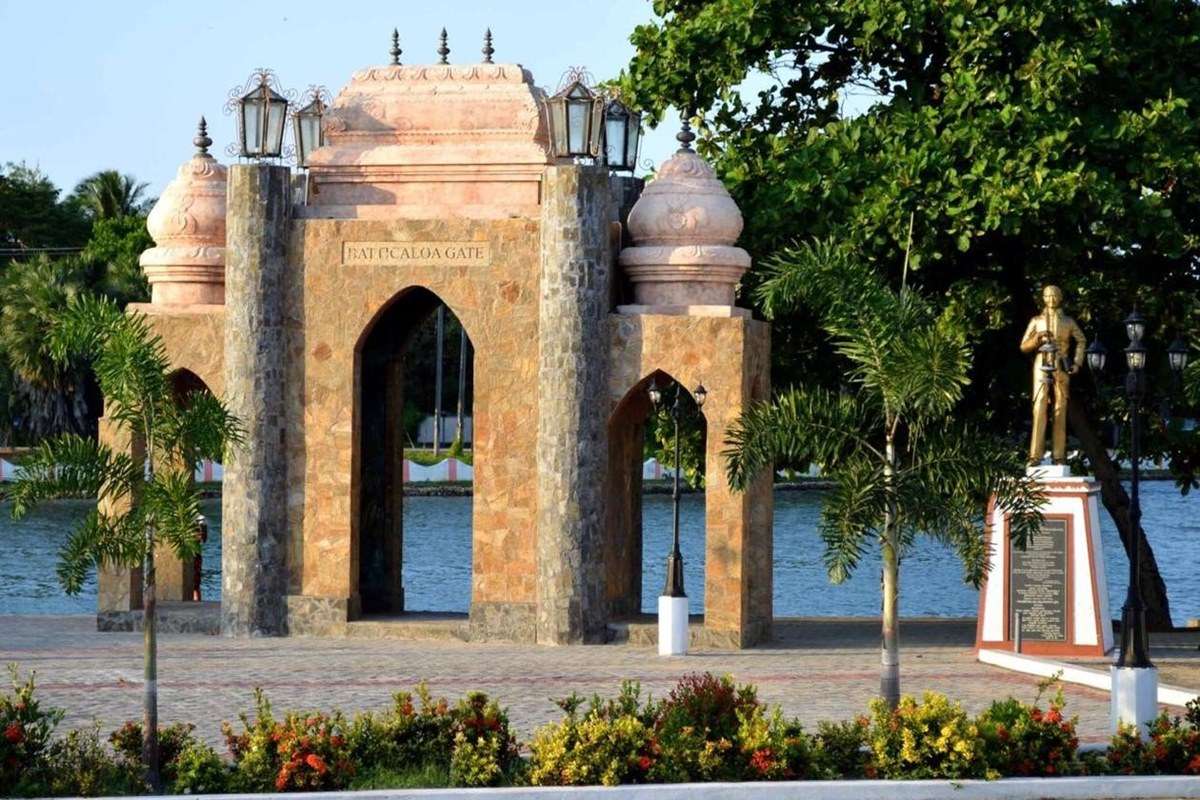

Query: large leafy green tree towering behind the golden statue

[623,0,1200,625]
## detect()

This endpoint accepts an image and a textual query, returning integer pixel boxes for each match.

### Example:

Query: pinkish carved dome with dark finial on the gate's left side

[140,118,227,306]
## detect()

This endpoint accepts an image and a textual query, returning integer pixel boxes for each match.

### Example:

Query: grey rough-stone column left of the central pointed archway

[221,164,292,636]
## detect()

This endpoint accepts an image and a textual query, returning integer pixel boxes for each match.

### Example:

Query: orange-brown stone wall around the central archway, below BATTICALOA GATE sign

[286,217,539,642]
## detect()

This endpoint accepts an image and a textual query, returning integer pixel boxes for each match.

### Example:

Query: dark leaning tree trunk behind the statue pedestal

[1067,397,1171,631]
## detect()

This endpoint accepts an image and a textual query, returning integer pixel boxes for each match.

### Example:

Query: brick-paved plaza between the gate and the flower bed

[0,616,1161,744]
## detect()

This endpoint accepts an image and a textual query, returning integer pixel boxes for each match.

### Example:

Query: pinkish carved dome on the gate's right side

[620,148,750,313]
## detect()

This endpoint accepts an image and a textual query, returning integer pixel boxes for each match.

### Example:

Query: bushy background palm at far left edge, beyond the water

[0,255,91,440]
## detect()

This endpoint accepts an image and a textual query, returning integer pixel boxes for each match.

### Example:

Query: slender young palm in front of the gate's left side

[10,295,242,792]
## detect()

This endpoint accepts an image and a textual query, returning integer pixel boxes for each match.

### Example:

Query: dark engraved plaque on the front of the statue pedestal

[1008,519,1068,642]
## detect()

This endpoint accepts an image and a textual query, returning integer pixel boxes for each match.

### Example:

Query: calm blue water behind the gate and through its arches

[0,482,1200,624]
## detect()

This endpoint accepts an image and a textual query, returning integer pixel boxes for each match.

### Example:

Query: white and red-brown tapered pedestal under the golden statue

[976,465,1112,656]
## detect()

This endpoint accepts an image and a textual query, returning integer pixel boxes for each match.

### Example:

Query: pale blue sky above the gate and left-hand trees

[0,0,678,194]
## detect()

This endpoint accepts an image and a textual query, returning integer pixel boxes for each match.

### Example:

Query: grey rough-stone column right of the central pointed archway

[538,164,613,644]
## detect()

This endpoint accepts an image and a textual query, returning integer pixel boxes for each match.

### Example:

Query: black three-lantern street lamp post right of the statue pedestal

[1087,311,1188,669]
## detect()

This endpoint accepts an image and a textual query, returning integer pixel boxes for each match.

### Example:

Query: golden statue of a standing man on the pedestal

[1021,287,1087,465]
